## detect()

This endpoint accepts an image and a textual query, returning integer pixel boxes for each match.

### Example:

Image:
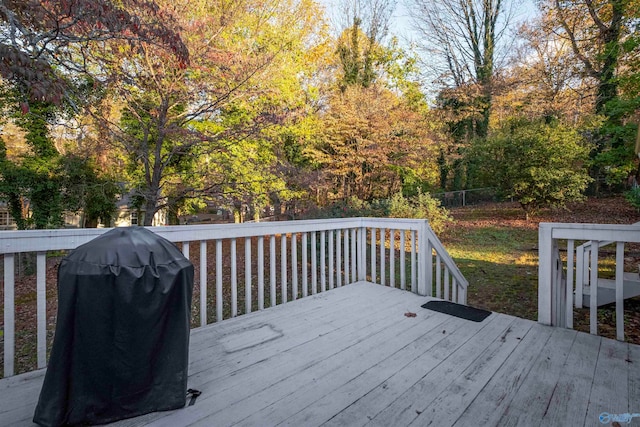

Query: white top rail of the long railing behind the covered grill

[0,218,426,254]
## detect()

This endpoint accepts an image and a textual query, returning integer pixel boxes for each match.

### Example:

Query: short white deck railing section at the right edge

[538,223,640,341]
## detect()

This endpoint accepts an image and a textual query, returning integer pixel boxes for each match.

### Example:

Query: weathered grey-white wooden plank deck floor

[0,283,640,427]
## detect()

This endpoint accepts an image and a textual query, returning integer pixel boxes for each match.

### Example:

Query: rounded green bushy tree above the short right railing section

[473,119,591,219]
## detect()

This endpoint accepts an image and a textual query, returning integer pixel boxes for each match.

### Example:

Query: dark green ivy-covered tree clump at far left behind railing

[0,95,116,229]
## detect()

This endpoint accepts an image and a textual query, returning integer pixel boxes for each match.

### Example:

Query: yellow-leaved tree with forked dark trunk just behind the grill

[101,0,328,225]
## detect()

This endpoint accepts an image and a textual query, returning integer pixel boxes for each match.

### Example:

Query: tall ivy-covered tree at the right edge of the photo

[539,0,640,191]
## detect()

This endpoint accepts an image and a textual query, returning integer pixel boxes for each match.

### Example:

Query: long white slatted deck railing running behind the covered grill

[0,218,468,377]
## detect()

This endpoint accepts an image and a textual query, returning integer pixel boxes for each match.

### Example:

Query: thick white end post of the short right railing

[538,223,554,325]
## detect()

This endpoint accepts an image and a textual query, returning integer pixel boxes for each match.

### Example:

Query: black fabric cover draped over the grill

[33,227,193,426]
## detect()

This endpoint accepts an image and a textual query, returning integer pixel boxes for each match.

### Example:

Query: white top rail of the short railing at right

[540,222,640,243]
